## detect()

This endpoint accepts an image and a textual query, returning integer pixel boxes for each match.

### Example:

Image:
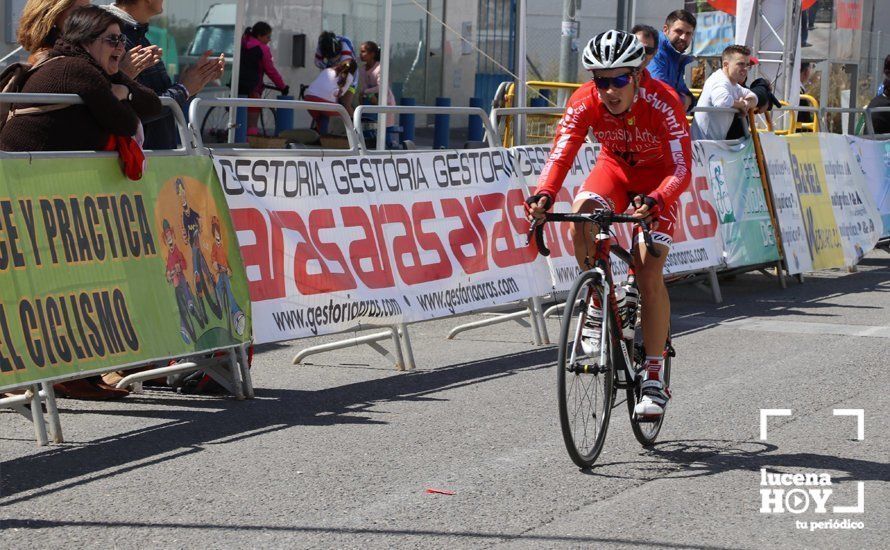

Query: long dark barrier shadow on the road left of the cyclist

[0,349,553,506]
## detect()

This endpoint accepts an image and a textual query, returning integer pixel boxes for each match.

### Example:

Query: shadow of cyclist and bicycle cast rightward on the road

[588,439,890,482]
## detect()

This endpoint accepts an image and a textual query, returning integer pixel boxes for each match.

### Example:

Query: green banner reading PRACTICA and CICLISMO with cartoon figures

[0,157,251,389]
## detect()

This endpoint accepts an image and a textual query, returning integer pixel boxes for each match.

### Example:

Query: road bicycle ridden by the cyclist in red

[529,210,675,468]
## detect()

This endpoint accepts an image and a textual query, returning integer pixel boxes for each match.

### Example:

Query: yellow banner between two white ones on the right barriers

[787,134,844,270]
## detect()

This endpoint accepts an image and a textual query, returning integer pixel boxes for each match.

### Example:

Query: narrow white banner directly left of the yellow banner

[759,132,813,275]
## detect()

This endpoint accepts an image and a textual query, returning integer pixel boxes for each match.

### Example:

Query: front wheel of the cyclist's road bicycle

[556,271,614,468]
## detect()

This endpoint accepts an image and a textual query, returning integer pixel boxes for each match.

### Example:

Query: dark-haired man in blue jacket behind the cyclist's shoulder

[649,10,696,110]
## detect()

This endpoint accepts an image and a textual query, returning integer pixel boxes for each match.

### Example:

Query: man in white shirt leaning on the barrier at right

[692,45,757,140]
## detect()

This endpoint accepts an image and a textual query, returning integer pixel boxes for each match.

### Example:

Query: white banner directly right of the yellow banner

[819,134,883,265]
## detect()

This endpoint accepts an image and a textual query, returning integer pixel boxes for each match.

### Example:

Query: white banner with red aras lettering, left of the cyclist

[214,149,550,343]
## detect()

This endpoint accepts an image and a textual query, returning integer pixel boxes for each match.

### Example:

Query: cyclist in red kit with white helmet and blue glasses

[526,30,692,417]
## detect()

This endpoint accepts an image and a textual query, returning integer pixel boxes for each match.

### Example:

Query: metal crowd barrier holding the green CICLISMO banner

[0,93,254,445]
